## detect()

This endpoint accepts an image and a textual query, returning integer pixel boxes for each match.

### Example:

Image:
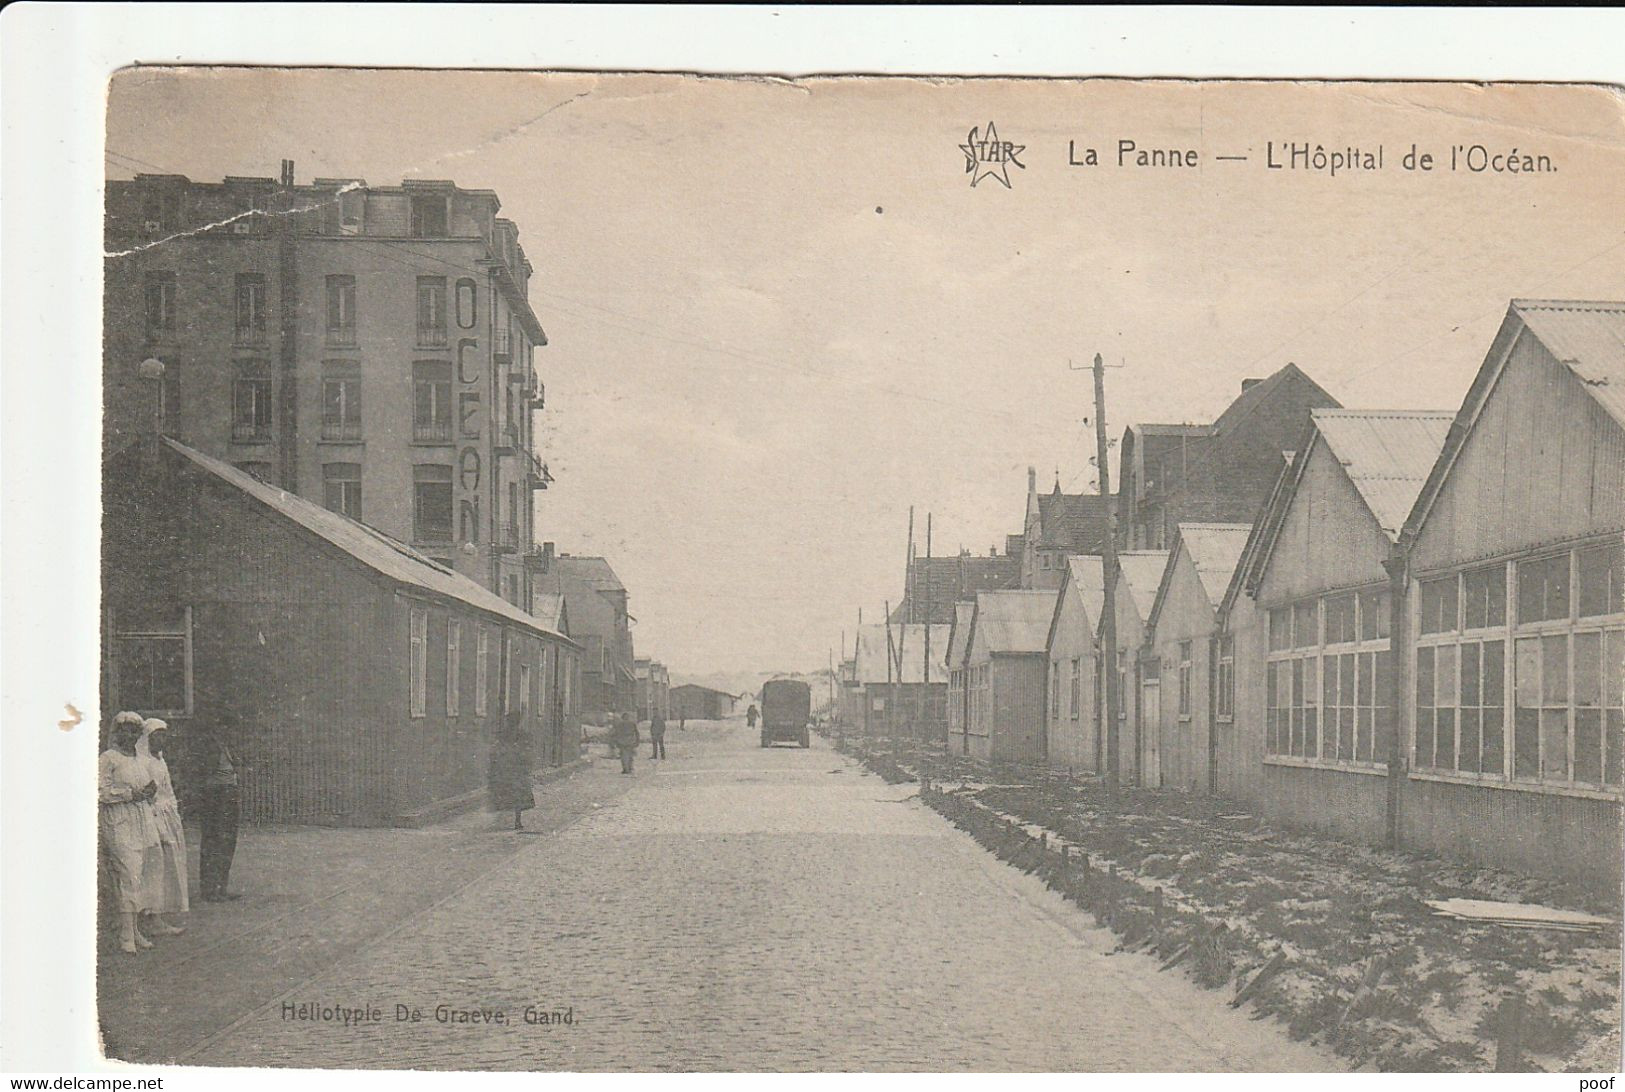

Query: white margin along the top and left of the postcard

[0,3,1625,1087]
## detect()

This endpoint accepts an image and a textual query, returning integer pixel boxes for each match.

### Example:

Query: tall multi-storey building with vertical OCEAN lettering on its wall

[102,161,551,609]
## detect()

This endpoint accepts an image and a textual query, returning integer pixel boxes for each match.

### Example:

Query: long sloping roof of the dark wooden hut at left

[164,437,569,640]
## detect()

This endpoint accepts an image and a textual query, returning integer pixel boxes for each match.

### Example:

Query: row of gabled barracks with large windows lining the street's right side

[947,301,1625,887]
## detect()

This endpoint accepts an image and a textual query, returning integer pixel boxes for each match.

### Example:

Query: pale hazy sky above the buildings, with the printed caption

[107,68,1625,676]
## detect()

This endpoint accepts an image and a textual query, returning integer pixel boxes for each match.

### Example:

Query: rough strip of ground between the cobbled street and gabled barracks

[840,736,1620,1073]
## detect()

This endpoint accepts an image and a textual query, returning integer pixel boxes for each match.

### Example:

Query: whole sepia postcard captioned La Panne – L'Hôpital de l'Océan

[7,6,1625,1087]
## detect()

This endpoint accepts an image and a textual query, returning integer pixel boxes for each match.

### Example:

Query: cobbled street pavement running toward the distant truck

[182,720,1339,1071]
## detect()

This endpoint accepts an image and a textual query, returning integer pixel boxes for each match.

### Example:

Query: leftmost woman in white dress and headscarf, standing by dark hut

[96,713,158,956]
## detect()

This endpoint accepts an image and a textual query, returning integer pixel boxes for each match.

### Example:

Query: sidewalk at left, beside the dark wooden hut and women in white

[98,754,629,1061]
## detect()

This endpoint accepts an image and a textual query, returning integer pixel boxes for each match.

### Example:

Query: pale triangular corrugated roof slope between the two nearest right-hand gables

[1311,410,1456,540]
